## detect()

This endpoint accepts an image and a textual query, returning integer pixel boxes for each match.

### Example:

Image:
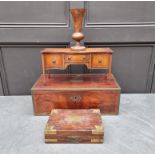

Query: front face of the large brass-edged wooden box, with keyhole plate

[32,90,119,115]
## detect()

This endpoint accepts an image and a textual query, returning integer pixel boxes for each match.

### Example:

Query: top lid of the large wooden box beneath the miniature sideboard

[31,74,120,91]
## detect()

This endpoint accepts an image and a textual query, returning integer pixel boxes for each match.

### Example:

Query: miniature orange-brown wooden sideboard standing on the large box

[41,48,113,75]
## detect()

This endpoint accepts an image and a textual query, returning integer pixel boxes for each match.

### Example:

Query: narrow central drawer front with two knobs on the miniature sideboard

[65,54,90,62]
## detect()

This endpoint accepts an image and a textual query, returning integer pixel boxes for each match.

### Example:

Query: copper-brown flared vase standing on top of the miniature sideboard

[71,8,85,50]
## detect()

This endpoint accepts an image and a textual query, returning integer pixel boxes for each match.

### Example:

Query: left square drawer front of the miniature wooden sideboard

[44,54,63,68]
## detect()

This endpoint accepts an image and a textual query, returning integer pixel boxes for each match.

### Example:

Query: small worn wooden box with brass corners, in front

[44,109,104,143]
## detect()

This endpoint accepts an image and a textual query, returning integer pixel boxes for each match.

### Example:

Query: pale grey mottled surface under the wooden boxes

[0,94,155,154]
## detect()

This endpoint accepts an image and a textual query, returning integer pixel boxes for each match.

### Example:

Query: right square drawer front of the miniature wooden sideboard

[92,54,109,68]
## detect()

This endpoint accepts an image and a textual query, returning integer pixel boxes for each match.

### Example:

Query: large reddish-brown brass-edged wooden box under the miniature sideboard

[32,74,120,115]
